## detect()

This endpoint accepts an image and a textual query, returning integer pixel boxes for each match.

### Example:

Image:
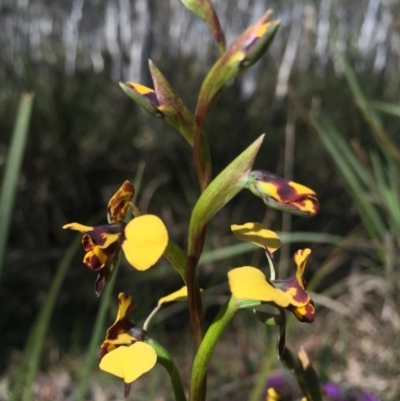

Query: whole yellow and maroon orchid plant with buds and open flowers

[63,0,319,401]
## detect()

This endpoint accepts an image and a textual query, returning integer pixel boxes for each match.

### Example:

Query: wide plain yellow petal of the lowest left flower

[100,342,157,383]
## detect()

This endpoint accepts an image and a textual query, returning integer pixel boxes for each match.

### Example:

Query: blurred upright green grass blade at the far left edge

[0,93,33,279]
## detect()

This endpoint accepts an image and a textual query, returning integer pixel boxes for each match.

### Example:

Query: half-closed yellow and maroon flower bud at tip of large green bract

[247,170,319,216]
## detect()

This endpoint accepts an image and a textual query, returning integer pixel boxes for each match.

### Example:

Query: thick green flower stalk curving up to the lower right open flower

[190,297,239,401]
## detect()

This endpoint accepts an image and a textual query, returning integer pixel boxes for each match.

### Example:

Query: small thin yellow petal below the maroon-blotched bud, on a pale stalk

[231,223,281,252]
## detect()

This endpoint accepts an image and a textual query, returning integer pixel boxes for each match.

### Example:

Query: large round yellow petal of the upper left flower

[122,214,168,270]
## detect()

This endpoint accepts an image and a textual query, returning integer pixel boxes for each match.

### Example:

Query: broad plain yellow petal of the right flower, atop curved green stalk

[228,266,291,308]
